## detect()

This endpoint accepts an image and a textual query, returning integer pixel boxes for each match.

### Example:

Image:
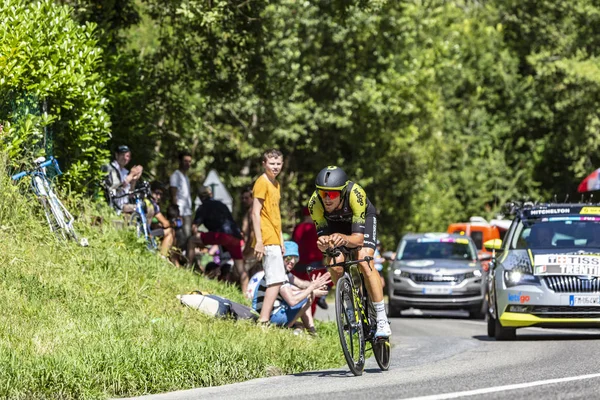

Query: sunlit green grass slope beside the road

[0,163,344,399]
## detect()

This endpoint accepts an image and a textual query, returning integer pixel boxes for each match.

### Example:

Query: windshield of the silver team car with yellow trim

[511,216,600,249]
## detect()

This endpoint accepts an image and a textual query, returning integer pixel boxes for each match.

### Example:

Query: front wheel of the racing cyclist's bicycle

[335,275,365,376]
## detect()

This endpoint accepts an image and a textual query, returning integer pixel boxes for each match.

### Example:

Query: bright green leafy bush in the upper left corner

[0,0,110,189]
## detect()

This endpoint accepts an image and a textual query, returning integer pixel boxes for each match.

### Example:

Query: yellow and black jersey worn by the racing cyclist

[308,182,377,248]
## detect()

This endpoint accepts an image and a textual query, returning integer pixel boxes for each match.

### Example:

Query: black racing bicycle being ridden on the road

[308,247,390,376]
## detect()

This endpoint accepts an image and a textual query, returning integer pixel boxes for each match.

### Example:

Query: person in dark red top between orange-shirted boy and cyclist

[292,207,327,314]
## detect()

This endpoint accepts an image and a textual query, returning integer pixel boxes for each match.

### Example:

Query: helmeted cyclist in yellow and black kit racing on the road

[308,166,392,338]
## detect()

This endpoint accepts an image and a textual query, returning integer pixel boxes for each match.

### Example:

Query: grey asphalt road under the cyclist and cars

[120,310,600,400]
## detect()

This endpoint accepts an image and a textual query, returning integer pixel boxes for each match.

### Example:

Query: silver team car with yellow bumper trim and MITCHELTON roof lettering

[486,204,600,340]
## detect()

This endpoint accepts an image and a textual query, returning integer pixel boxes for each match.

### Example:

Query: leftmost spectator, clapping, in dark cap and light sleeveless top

[104,145,144,214]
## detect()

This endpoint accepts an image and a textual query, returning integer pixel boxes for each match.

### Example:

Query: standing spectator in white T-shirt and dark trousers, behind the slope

[170,151,192,248]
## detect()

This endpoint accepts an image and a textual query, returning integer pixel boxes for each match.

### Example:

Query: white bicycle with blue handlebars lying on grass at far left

[12,156,88,246]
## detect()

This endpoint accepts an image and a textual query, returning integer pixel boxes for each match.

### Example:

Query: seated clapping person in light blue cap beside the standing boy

[252,241,331,335]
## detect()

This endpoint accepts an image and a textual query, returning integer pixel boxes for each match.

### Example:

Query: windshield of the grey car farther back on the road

[397,239,477,260]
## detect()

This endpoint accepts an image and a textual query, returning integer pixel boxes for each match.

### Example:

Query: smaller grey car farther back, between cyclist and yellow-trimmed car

[388,233,487,319]
